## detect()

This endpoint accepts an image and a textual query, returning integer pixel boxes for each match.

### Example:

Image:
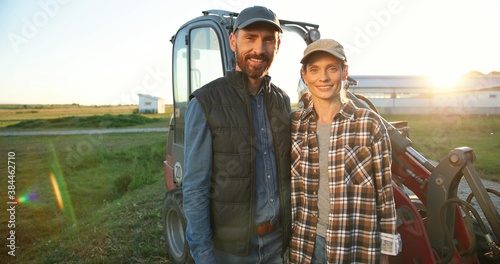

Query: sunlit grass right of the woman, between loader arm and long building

[384,115,500,182]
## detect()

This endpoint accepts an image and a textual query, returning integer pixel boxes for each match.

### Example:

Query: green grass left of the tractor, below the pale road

[0,133,172,263]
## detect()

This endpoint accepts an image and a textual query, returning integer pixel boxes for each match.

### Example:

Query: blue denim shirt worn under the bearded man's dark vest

[182,93,279,263]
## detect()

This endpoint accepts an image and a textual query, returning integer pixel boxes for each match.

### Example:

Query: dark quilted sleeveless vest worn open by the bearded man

[191,71,291,256]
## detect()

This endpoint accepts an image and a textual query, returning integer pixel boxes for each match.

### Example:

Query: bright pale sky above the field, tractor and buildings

[0,0,500,105]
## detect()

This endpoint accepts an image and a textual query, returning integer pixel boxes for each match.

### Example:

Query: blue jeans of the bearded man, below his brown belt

[215,227,283,264]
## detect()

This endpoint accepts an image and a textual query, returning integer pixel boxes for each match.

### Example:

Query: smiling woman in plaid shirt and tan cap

[290,39,400,264]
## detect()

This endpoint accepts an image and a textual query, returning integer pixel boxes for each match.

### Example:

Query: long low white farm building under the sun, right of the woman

[349,75,500,114]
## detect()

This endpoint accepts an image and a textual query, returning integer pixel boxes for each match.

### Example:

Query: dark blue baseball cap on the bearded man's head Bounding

[233,6,283,33]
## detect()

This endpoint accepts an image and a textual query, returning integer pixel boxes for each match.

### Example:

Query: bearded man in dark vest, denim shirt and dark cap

[182,6,291,263]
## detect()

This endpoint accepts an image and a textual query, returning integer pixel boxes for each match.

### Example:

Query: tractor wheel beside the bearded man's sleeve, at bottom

[162,188,194,264]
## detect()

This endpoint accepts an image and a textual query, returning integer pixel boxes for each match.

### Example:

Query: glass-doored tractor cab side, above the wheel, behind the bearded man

[165,16,234,189]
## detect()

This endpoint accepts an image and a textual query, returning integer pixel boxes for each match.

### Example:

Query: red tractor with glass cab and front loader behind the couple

[162,10,500,263]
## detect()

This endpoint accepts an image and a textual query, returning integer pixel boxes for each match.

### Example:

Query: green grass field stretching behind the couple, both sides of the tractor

[0,104,500,263]
